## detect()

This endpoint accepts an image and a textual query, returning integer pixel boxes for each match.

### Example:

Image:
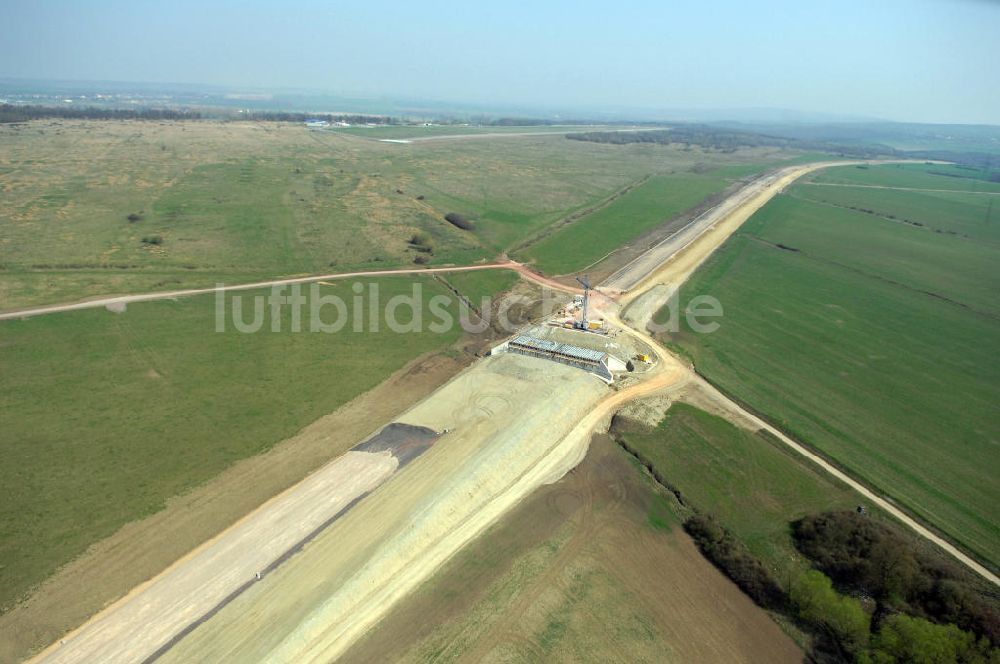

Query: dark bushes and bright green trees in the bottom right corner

[684,512,1000,663]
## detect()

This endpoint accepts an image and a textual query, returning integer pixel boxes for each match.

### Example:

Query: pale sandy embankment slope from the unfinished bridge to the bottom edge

[162,354,619,662]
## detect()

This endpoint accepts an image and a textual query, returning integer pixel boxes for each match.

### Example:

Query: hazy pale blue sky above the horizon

[0,0,1000,124]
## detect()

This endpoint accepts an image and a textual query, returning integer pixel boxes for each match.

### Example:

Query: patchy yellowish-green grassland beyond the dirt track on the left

[0,121,794,309]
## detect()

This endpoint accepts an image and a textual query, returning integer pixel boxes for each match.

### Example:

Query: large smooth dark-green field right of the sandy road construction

[664,166,1000,568]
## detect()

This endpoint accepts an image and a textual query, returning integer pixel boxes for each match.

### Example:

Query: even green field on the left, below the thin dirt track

[0,278,474,607]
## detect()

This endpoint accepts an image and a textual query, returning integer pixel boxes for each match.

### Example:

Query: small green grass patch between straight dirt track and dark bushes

[624,403,859,572]
